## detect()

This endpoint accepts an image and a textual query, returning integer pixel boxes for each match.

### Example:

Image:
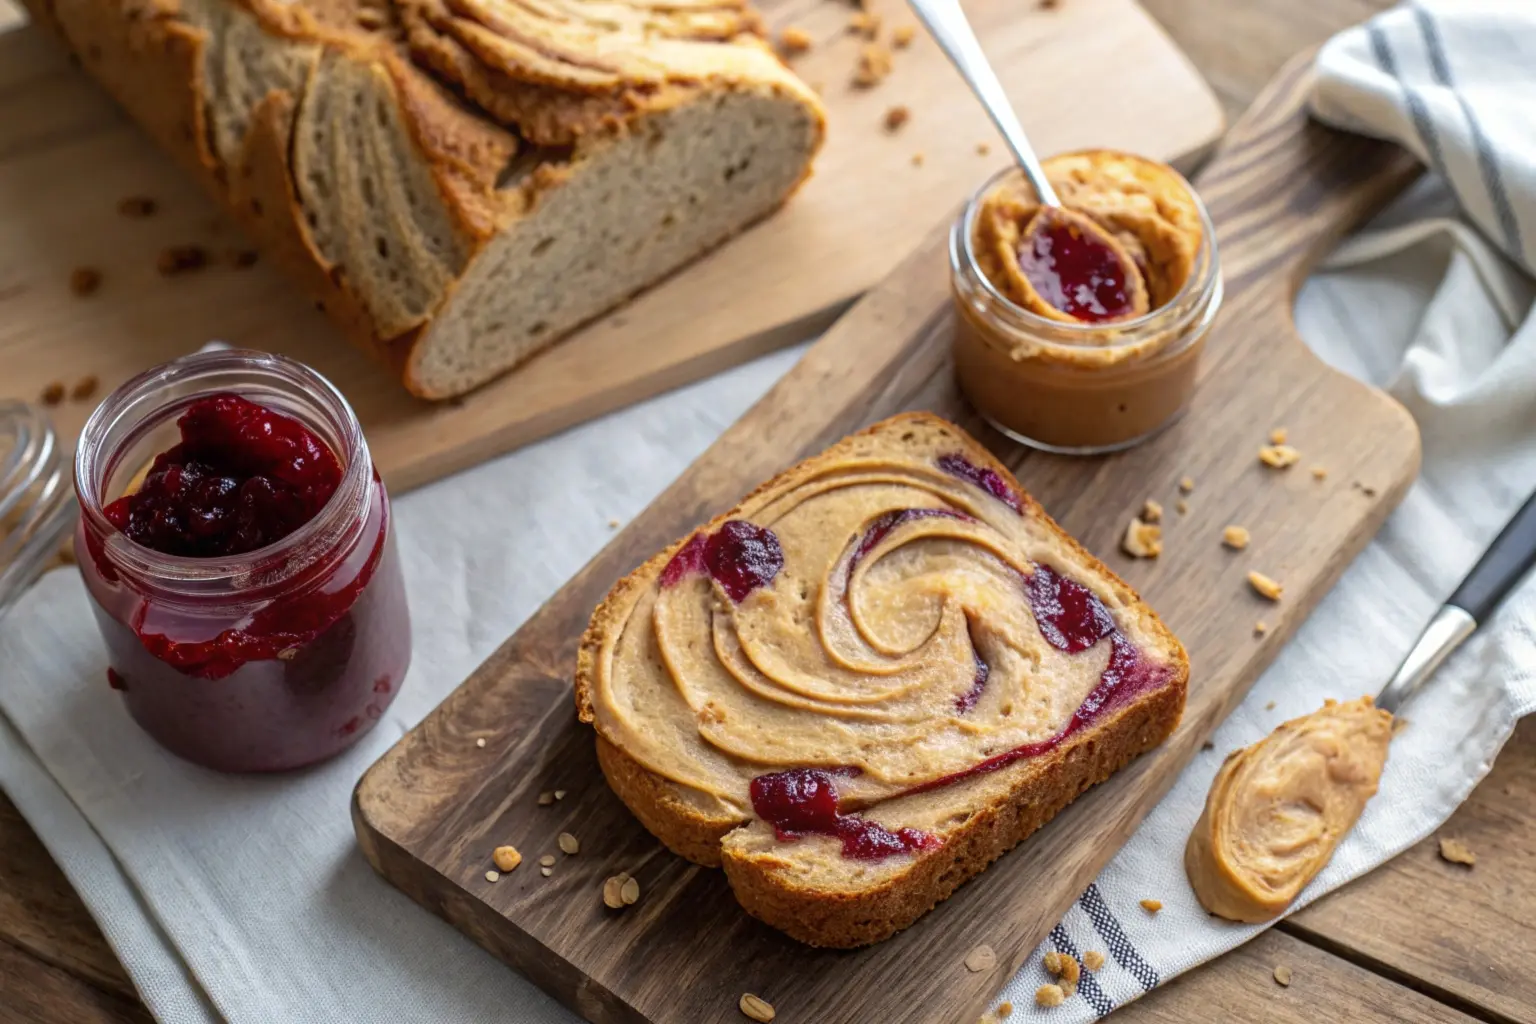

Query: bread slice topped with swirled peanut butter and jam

[576,413,1189,947]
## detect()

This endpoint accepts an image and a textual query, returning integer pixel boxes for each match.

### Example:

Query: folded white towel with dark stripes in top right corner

[1312,0,1536,272]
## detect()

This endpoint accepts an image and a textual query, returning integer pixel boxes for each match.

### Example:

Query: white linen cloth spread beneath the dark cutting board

[0,5,1536,1024]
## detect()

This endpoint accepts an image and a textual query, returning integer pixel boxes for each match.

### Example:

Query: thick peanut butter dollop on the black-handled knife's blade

[1184,697,1392,923]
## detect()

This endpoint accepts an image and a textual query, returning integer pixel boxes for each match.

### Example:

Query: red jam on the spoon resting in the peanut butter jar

[1018,215,1135,324]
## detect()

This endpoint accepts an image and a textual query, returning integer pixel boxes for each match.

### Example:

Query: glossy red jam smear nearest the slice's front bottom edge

[751,768,943,860]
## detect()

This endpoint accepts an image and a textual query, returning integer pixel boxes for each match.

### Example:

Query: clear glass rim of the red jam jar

[75,348,373,597]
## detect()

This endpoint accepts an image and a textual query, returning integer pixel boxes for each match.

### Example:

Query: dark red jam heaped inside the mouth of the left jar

[104,393,341,559]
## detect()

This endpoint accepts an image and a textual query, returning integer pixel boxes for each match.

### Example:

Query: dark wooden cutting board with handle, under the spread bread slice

[353,54,1419,1024]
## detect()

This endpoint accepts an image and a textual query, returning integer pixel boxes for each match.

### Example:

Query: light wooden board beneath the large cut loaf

[0,0,1223,491]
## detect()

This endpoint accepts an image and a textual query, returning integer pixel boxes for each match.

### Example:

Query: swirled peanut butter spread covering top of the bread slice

[591,448,1167,817]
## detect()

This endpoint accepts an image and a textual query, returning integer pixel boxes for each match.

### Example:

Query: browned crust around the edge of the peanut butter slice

[574,411,1189,949]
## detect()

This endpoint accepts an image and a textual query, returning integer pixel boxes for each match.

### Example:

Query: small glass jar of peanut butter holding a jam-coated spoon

[949,150,1221,454]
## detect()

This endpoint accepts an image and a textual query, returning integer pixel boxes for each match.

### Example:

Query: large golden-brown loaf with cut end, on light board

[23,0,825,398]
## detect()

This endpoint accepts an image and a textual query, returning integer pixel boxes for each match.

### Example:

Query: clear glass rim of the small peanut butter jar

[949,158,1221,353]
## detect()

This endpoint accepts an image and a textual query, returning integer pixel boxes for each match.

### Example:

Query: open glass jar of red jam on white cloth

[75,350,410,771]
